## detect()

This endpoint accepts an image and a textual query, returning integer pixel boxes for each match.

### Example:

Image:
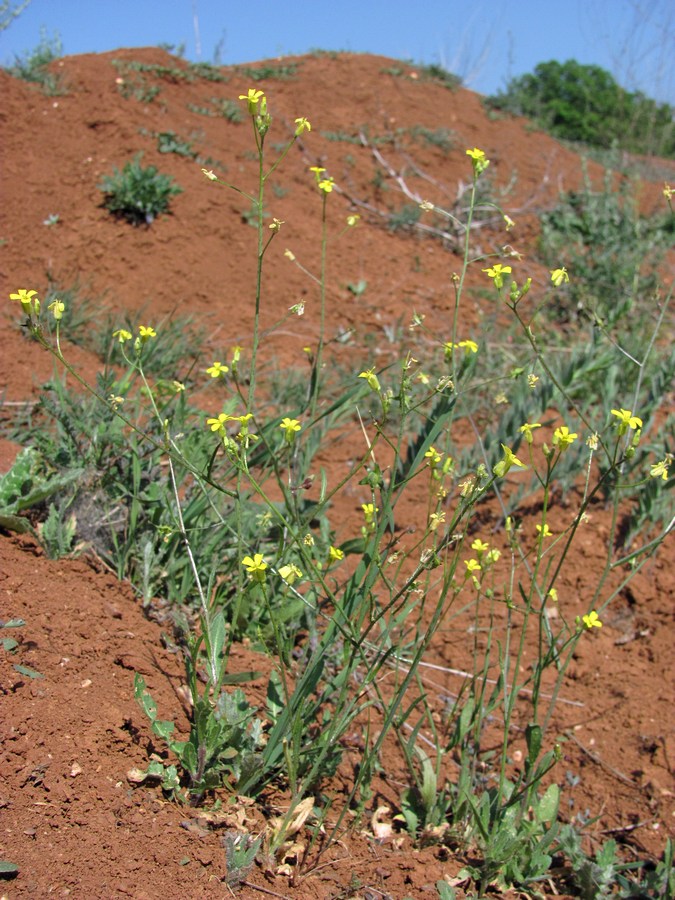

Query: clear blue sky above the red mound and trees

[0,0,675,105]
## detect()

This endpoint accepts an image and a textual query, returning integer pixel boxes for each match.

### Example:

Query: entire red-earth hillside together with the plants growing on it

[0,51,673,897]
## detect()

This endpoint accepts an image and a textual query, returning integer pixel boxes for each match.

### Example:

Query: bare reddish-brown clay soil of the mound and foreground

[0,49,675,900]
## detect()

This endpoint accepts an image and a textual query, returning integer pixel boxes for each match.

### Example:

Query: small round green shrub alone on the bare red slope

[99,155,182,225]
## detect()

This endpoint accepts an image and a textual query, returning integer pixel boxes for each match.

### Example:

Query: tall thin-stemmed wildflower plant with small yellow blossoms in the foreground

[11,87,672,891]
